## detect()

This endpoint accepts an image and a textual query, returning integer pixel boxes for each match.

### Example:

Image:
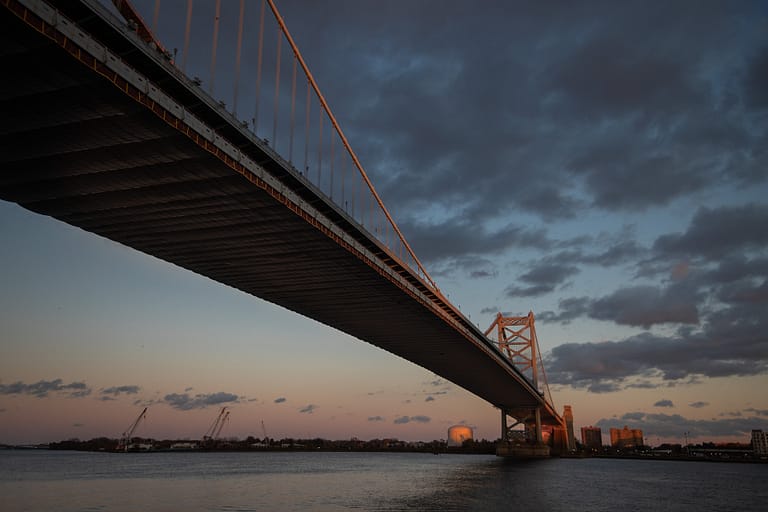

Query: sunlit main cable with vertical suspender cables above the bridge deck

[108,0,441,295]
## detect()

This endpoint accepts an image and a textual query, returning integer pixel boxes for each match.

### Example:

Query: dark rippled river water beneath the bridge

[0,450,768,512]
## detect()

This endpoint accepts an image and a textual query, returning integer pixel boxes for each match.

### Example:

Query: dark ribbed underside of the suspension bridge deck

[0,2,552,421]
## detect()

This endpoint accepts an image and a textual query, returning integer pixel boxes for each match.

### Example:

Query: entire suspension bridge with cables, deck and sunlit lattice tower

[0,0,573,455]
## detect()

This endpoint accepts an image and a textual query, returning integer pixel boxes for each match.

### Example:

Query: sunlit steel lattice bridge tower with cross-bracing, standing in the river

[485,311,561,457]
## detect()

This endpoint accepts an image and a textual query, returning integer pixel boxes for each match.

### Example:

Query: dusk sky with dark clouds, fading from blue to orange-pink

[0,0,768,444]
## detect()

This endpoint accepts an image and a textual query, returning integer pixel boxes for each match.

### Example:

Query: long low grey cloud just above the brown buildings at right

[595,412,765,444]
